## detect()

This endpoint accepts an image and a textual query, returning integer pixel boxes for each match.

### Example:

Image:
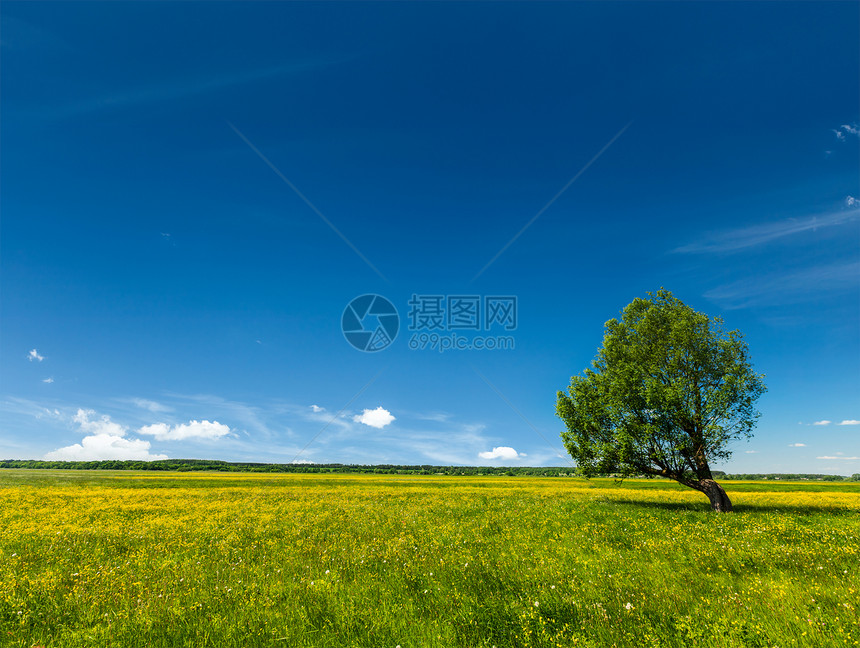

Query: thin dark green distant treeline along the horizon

[0,459,860,481]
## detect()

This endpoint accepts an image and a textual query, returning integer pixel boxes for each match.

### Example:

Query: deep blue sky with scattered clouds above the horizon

[0,2,860,474]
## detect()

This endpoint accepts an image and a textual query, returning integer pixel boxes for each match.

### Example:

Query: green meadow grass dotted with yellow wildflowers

[0,470,860,648]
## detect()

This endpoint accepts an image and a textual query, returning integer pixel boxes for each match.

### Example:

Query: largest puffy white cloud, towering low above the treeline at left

[45,409,167,461]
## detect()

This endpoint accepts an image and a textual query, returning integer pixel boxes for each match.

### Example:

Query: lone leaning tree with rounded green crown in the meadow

[556,288,766,512]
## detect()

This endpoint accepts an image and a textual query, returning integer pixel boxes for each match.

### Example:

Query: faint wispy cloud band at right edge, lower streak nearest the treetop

[704,261,860,310]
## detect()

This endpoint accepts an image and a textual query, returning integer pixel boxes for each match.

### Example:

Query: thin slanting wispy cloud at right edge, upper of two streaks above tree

[673,208,860,254]
